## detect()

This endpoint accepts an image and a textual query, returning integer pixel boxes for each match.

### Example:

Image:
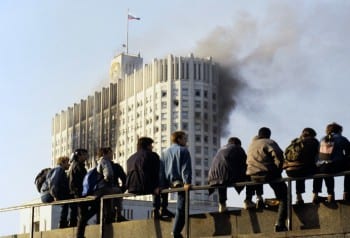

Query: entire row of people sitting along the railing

[41,123,350,238]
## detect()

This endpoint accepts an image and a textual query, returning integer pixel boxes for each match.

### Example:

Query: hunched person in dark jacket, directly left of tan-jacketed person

[208,137,263,212]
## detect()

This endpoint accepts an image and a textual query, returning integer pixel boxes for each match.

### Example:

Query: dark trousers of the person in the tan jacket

[251,173,288,226]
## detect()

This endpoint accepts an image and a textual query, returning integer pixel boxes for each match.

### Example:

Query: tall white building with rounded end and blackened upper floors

[52,54,220,203]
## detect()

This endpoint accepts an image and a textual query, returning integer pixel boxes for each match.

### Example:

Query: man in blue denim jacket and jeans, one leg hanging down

[161,131,192,238]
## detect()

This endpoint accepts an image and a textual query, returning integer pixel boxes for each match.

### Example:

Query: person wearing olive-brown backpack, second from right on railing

[283,127,319,205]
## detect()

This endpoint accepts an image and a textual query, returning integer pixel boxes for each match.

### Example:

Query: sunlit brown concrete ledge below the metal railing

[6,201,350,238]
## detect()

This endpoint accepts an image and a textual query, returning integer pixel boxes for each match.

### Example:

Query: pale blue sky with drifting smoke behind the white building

[0,0,350,235]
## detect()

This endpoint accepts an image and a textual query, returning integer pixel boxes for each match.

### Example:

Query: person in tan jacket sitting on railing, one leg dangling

[247,127,287,232]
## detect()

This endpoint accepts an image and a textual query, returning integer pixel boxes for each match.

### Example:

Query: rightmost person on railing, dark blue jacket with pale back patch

[312,122,350,203]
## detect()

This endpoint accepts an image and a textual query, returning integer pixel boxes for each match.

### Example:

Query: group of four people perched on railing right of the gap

[208,122,350,232]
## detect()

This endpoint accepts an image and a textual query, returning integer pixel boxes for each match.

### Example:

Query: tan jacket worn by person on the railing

[246,136,283,175]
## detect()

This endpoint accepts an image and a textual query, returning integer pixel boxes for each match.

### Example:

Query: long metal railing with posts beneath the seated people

[0,171,350,238]
